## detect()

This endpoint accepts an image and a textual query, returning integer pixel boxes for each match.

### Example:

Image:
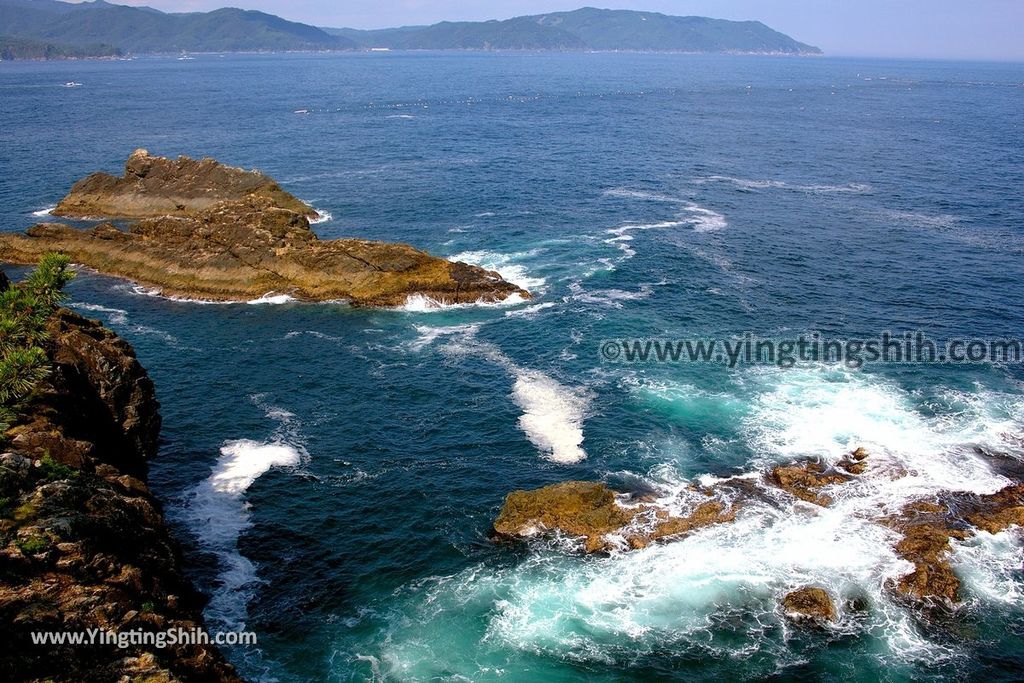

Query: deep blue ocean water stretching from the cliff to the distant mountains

[0,53,1024,681]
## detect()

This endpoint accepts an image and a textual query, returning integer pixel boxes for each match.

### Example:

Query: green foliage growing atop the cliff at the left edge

[0,254,75,442]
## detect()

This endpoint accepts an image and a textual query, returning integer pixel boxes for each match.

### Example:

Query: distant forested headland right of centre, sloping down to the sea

[325,7,821,54]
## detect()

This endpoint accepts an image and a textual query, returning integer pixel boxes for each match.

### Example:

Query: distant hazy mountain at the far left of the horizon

[0,0,357,52]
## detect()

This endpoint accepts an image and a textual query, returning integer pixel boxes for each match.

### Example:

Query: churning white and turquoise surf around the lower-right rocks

[382,367,1024,678]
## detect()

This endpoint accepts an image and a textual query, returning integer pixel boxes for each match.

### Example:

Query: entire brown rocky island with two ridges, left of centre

[0,150,529,306]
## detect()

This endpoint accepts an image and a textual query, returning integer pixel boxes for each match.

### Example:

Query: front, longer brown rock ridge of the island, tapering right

[0,197,529,306]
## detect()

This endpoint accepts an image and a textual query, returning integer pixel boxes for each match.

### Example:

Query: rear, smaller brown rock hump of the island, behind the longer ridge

[53,150,317,218]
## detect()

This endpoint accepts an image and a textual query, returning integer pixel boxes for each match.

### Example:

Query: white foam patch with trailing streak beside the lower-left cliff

[184,396,305,630]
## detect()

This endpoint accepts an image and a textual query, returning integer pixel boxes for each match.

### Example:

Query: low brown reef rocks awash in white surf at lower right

[494,449,1024,621]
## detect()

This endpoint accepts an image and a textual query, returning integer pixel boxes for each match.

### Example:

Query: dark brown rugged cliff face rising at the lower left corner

[0,278,239,681]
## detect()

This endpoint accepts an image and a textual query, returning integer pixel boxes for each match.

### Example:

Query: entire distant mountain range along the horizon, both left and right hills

[0,0,820,58]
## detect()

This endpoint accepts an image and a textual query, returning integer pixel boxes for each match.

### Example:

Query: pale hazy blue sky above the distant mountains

[83,0,1024,60]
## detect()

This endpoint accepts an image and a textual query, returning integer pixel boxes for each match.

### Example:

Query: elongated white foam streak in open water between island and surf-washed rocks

[411,326,591,463]
